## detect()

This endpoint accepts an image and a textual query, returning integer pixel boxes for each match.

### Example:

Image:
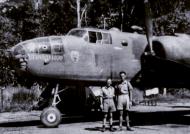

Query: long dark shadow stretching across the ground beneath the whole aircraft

[0,110,190,131]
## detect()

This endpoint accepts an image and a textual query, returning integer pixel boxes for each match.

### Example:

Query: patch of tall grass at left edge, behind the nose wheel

[0,86,39,112]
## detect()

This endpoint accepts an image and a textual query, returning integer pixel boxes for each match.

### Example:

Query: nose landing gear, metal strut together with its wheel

[40,84,64,128]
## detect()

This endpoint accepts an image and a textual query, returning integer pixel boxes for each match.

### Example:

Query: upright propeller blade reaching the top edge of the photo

[144,0,154,54]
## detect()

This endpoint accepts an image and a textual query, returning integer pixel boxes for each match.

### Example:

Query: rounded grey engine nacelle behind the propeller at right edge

[153,34,190,65]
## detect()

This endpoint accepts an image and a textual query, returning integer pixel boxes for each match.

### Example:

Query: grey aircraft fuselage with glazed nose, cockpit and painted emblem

[13,28,147,82]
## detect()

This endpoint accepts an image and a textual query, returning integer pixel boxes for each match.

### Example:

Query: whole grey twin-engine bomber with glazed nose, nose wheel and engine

[7,25,190,127]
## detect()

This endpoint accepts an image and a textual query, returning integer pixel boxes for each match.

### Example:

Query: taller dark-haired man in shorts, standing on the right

[117,72,133,131]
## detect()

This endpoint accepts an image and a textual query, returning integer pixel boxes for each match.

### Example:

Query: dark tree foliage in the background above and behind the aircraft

[0,0,190,84]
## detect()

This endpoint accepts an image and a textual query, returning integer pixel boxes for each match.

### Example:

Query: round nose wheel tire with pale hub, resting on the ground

[40,107,61,128]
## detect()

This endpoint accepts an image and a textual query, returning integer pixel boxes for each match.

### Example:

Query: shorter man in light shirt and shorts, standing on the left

[100,78,116,132]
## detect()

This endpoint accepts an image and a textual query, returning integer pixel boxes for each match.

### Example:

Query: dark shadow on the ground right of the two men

[131,110,190,126]
